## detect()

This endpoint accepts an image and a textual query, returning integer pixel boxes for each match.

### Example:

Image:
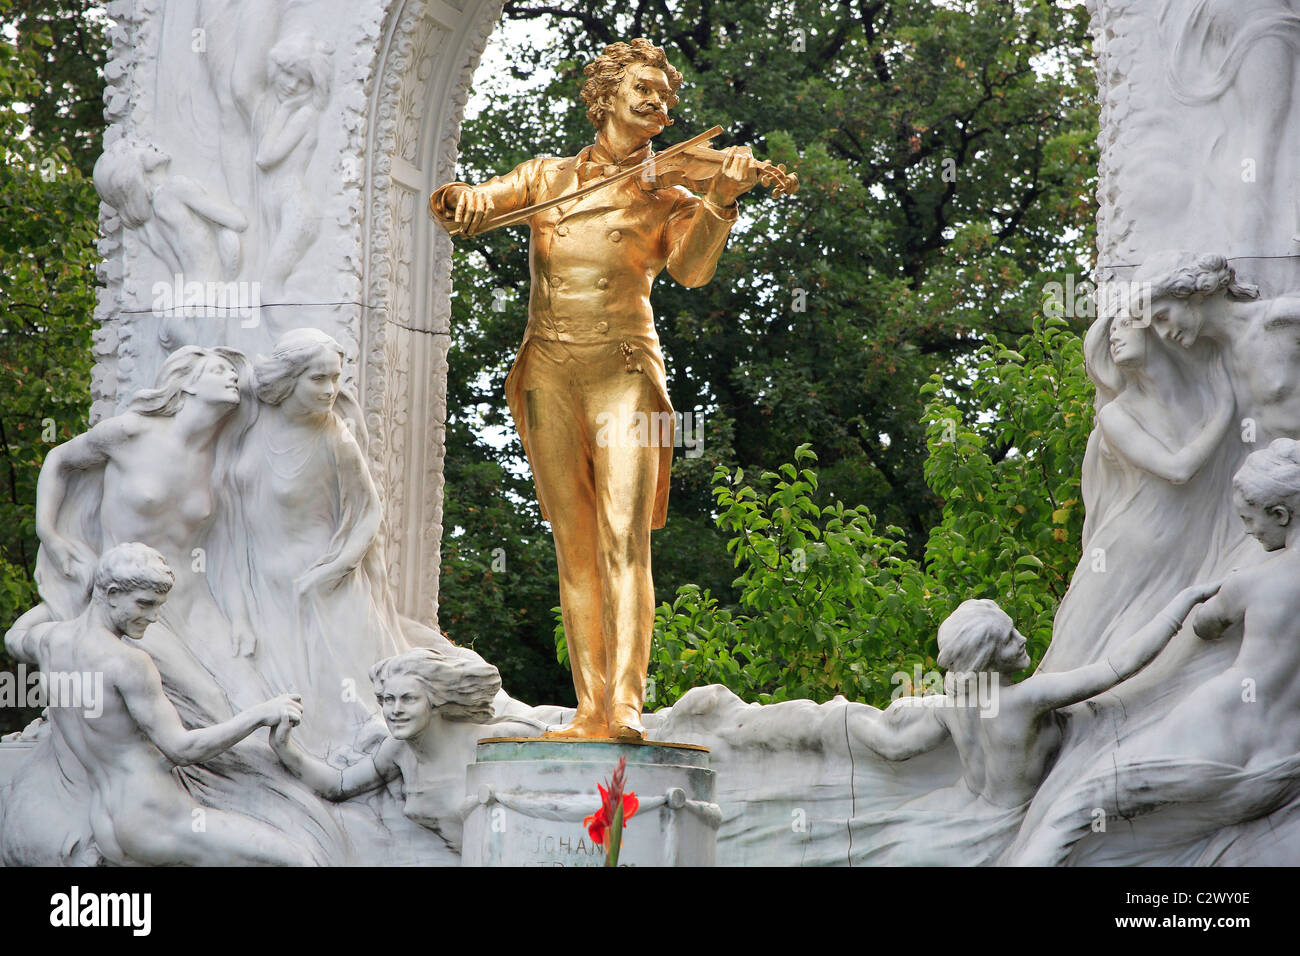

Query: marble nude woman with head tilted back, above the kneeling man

[36,346,254,719]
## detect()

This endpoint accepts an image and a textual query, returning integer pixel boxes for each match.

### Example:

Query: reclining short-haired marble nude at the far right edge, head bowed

[1010,438,1300,865]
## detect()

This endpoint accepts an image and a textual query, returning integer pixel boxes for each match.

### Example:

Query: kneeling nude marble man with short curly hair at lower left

[5,542,312,866]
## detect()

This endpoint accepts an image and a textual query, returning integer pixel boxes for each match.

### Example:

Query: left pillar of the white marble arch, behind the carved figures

[91,0,503,623]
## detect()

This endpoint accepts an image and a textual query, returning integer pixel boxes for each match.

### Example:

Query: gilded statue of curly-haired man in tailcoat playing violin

[429,39,758,740]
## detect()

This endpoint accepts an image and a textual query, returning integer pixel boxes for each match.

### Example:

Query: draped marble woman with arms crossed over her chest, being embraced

[1043,313,1235,670]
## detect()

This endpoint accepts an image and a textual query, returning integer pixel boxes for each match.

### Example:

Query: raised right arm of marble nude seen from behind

[1021,583,1219,713]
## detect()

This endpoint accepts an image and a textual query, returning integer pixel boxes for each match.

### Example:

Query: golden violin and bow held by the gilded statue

[429,126,800,235]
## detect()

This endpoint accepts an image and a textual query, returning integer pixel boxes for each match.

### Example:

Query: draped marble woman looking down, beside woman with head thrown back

[205,329,390,743]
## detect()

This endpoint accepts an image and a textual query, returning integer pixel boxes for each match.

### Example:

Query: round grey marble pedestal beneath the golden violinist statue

[462,737,722,866]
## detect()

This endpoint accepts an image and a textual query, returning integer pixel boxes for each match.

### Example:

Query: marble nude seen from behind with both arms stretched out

[849,584,1218,865]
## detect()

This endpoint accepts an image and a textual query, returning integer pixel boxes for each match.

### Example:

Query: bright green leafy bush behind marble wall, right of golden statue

[651,319,1092,706]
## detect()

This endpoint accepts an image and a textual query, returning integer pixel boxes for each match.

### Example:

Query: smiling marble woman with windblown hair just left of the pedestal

[270,648,542,852]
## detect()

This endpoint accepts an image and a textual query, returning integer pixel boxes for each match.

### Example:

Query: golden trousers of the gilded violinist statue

[520,338,672,726]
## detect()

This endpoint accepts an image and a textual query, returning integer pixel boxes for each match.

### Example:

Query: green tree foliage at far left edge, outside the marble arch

[0,0,103,730]
